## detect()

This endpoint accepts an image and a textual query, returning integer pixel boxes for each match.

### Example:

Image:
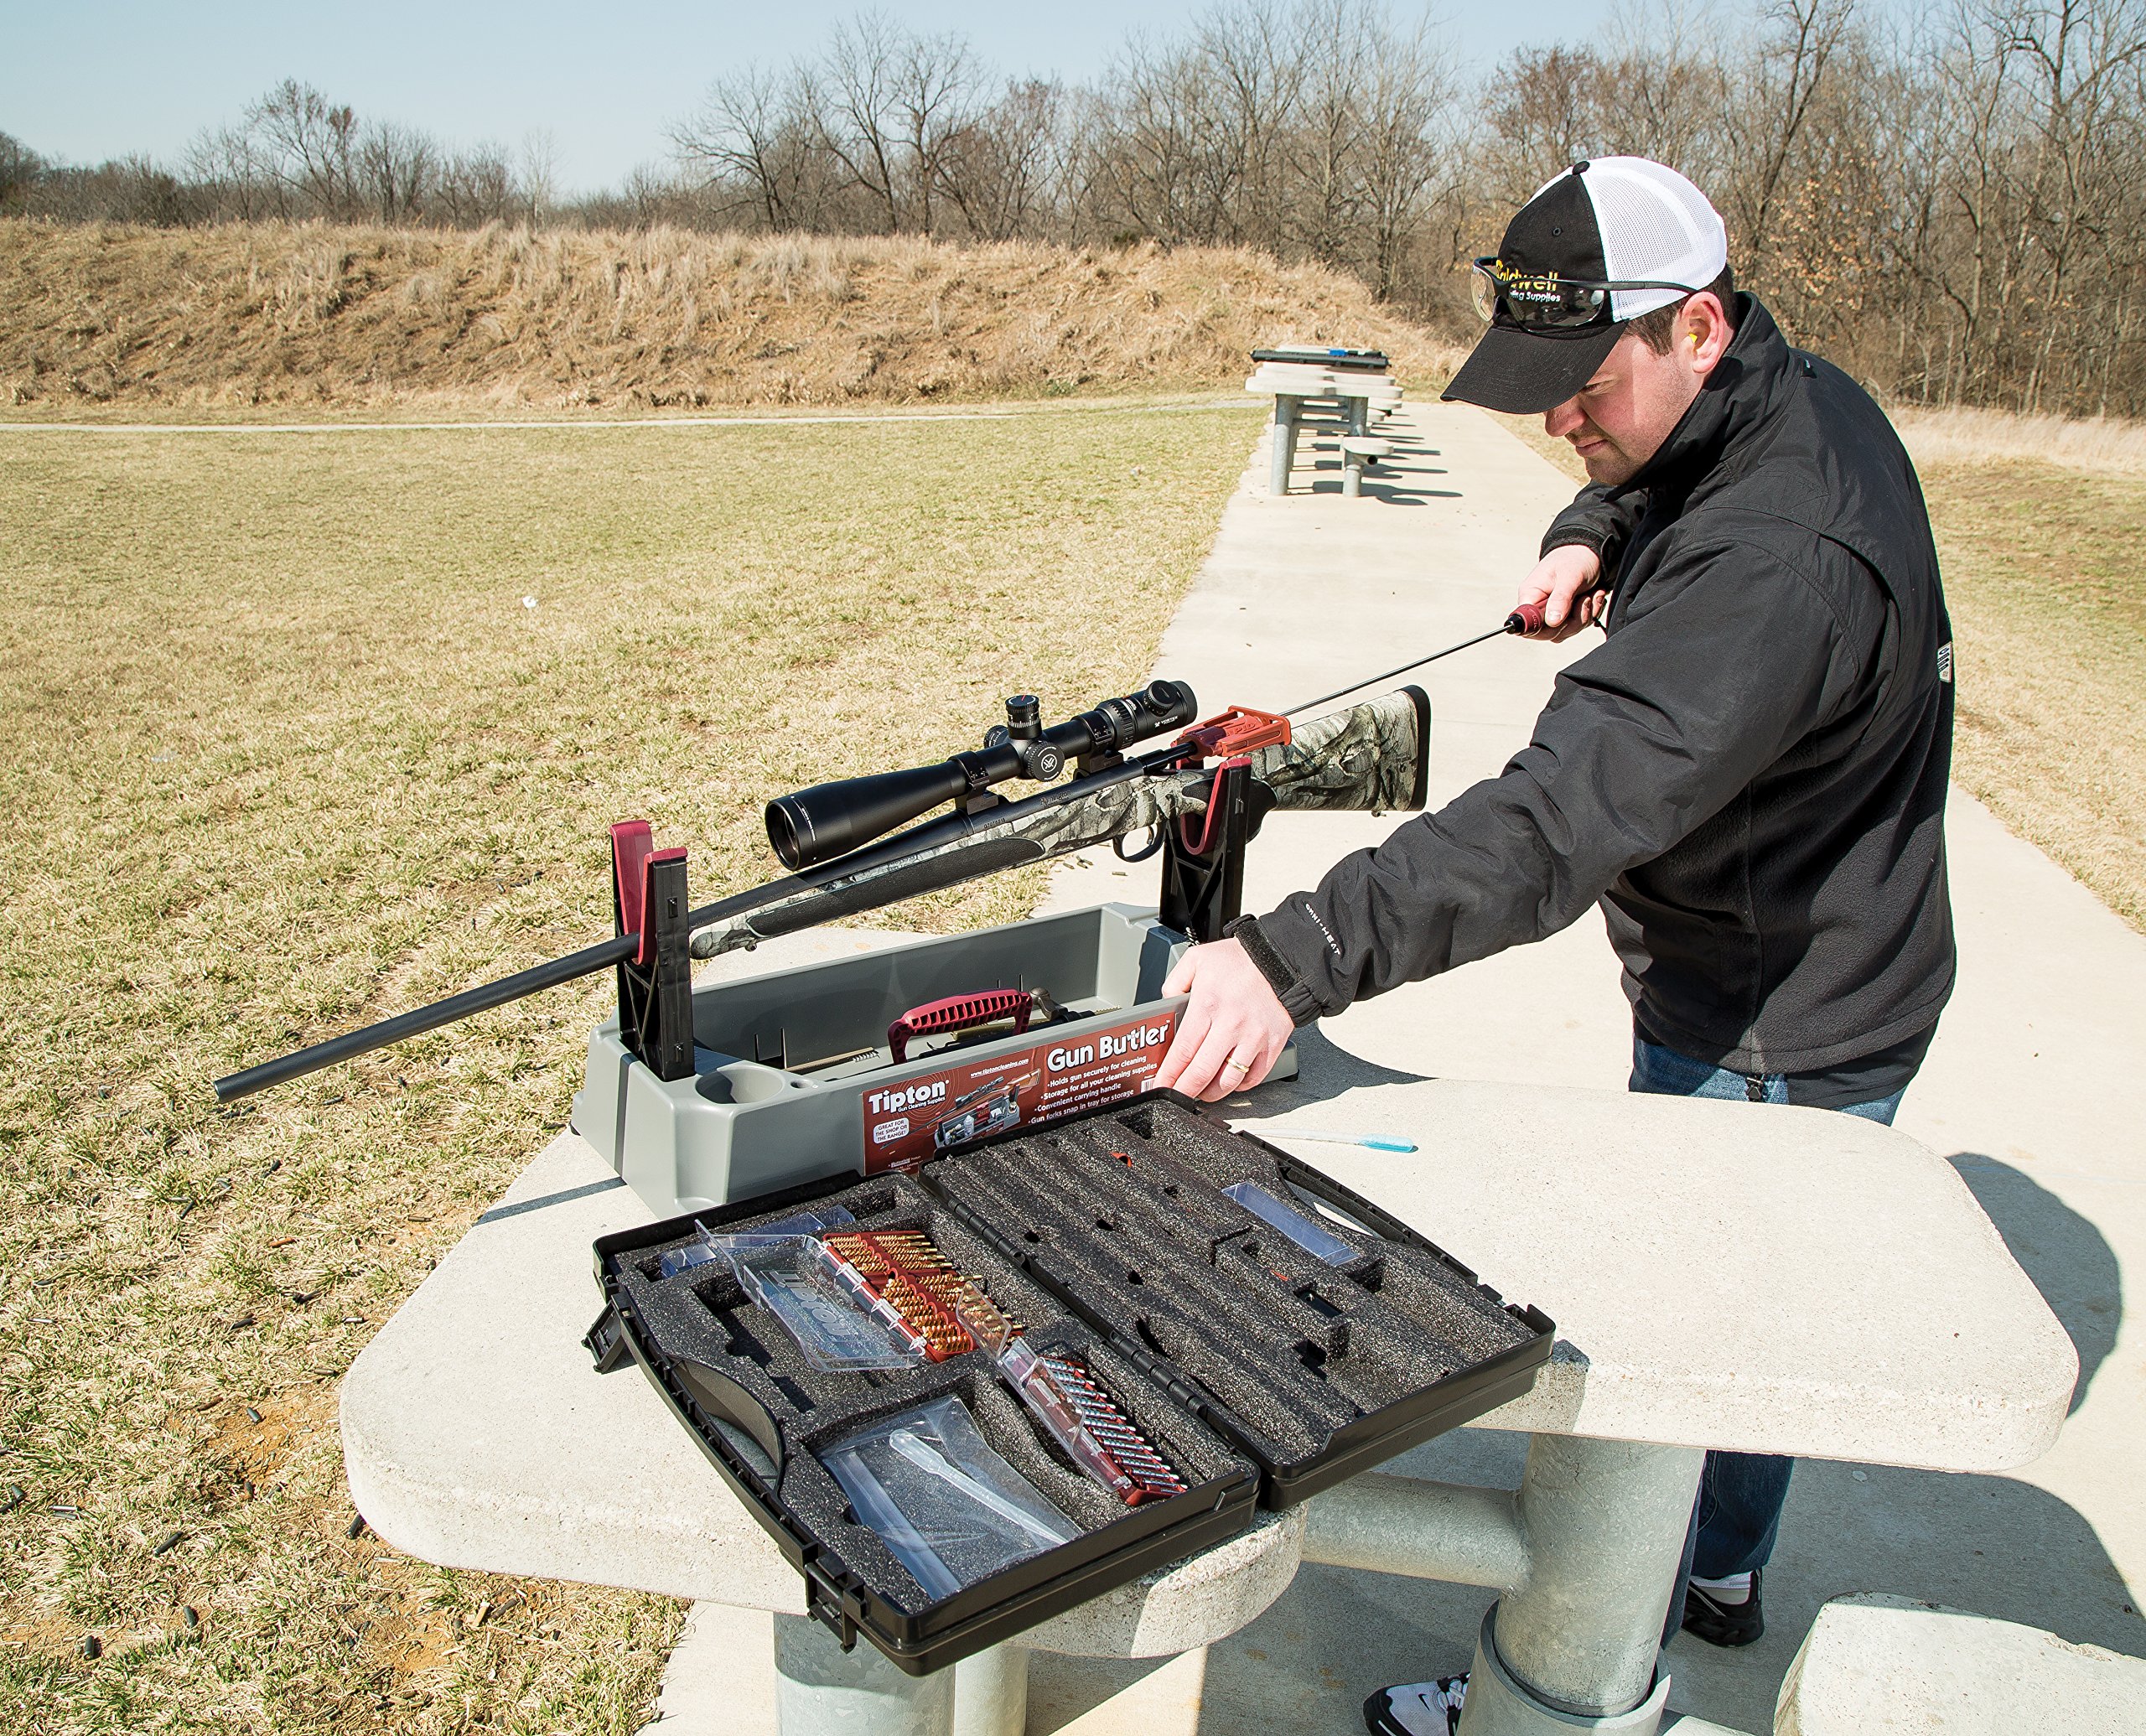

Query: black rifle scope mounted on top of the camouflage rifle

[768,681,1200,869]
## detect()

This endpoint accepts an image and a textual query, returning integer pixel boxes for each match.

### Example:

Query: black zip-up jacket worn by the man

[1236,296,1953,1073]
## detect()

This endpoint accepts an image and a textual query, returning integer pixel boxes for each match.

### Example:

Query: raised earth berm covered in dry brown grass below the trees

[0,219,1449,417]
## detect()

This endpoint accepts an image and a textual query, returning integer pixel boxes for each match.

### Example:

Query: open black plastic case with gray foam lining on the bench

[590,1092,1553,1674]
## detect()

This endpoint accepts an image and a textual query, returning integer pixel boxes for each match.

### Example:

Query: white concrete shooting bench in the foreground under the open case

[341,931,2077,1736]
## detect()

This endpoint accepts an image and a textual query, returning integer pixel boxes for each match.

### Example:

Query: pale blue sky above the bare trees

[0,0,1599,191]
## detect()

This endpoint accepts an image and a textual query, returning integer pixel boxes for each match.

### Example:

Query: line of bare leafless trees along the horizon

[0,0,2146,414]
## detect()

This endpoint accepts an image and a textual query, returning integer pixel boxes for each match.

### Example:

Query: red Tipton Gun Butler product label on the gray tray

[865,1008,1178,1176]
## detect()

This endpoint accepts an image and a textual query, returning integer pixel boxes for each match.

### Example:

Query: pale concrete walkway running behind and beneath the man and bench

[1030,403,2146,1736]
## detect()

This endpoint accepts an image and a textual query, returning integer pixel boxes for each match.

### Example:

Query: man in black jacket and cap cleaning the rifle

[1157,157,1953,1736]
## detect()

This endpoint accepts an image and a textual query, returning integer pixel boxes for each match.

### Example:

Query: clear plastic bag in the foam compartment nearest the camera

[820,1397,1080,1599]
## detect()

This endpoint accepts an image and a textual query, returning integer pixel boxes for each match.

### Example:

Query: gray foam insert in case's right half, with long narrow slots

[925,1103,1534,1468]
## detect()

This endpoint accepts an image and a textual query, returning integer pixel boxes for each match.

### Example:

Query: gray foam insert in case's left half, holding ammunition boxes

[618,1176,1251,1614]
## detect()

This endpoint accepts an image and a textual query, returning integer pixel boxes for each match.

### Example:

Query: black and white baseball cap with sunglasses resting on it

[1444,157,1729,414]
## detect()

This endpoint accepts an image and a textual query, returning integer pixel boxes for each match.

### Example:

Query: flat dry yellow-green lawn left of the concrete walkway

[0,407,1257,1736]
